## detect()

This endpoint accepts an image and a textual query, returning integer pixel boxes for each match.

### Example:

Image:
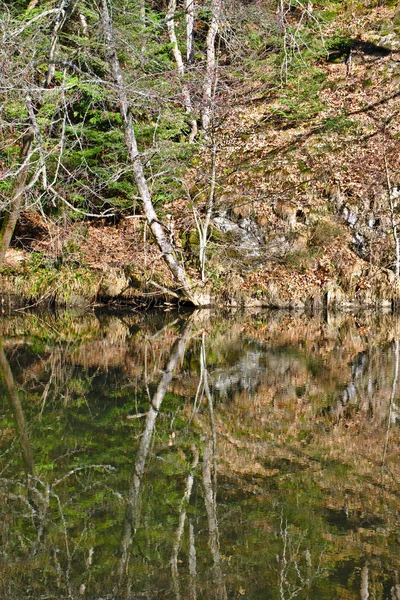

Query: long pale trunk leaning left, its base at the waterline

[103,0,206,306]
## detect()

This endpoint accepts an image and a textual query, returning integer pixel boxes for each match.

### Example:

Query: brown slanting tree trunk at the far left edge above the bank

[0,128,34,265]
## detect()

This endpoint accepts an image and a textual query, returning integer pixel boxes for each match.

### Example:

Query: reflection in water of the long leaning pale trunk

[118,323,191,586]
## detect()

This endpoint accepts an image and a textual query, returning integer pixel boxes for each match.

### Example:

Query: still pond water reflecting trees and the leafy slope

[0,311,400,600]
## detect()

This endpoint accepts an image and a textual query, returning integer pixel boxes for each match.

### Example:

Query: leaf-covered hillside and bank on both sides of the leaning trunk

[0,2,400,308]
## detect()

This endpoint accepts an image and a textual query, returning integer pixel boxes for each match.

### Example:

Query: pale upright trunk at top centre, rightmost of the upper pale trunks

[202,0,221,137]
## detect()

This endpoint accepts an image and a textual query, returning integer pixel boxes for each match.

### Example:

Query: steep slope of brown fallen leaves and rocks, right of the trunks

[179,3,400,306]
